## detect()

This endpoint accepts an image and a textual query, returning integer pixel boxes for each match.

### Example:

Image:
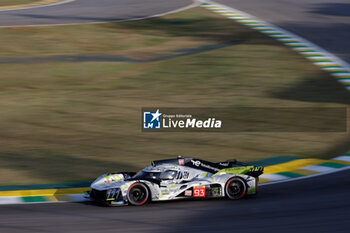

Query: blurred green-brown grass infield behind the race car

[0,9,350,185]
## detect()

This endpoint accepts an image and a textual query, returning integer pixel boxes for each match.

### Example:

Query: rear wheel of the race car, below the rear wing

[225,177,247,200]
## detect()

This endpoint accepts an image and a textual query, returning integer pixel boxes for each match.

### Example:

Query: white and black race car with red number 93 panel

[85,156,264,206]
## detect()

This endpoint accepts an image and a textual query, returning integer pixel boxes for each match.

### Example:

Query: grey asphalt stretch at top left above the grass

[0,0,193,26]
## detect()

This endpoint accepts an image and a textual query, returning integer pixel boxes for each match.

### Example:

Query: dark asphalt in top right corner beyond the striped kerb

[216,0,350,62]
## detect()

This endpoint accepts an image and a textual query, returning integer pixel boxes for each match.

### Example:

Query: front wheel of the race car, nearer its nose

[127,182,150,205]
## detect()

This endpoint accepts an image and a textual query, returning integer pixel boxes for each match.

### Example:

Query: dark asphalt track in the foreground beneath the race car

[0,169,350,233]
